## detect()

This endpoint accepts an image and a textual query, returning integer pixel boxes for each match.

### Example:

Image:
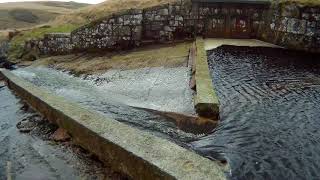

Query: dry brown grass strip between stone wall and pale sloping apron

[26,43,191,74]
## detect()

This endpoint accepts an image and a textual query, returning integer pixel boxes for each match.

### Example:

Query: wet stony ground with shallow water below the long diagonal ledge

[0,82,124,180]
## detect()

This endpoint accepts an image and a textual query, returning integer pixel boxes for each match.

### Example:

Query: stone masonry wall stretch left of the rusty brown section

[25,1,194,54]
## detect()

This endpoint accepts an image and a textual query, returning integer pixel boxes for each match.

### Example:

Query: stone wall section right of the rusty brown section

[259,2,320,52]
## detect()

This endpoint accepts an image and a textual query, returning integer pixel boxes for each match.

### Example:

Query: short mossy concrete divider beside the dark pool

[195,38,220,119]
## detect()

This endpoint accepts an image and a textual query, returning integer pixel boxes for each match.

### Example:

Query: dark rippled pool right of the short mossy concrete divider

[192,46,320,180]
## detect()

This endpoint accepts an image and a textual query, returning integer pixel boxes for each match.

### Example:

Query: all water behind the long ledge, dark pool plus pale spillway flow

[8,46,320,180]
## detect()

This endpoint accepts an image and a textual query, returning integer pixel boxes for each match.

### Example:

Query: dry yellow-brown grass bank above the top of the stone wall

[52,0,179,24]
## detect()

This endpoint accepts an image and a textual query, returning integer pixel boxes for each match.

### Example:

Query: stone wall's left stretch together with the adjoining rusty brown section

[26,0,268,54]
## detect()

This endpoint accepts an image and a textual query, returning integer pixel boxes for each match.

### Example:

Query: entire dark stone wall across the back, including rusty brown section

[25,0,320,54]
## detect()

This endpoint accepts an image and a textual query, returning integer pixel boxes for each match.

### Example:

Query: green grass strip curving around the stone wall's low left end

[9,24,78,62]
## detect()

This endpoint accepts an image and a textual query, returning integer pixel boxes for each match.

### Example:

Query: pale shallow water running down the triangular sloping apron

[13,67,198,146]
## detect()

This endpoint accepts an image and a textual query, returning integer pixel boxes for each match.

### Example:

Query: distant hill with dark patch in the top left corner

[0,1,88,30]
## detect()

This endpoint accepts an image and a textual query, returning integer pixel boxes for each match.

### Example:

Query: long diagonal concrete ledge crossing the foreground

[0,70,226,179]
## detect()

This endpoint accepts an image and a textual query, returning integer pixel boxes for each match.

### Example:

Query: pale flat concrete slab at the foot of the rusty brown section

[204,38,280,51]
